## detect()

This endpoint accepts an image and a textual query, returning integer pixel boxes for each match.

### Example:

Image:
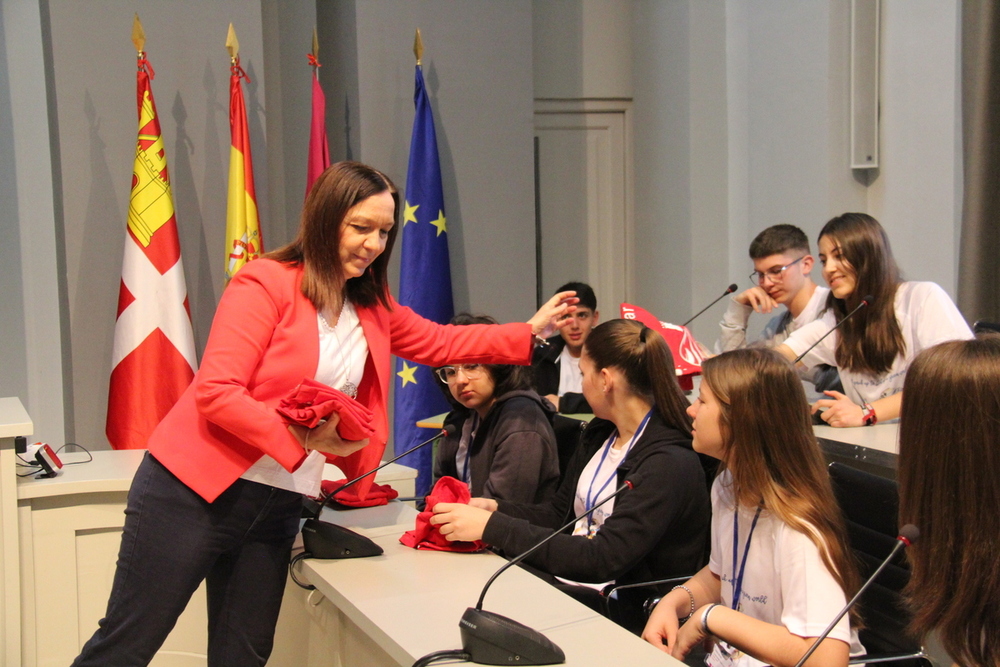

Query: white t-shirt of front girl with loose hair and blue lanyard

[706,471,864,667]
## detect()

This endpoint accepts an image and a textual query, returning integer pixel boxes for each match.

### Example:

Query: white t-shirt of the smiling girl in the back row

[785,282,973,405]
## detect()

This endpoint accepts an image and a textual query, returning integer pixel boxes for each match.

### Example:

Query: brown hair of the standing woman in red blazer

[264,161,399,312]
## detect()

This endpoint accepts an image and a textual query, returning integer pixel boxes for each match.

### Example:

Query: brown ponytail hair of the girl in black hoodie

[583,320,691,435]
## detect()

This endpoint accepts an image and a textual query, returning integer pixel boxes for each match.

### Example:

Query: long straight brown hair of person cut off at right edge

[899,336,1000,667]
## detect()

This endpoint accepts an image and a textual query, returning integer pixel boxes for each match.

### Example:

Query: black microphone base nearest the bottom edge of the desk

[458,607,566,665]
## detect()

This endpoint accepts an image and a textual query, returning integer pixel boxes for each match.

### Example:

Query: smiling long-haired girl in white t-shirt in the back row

[778,213,972,426]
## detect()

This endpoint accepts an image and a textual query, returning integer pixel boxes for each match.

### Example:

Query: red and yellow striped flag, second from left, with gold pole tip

[226,23,264,280]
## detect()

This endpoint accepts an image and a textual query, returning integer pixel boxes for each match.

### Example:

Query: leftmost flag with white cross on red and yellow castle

[105,24,197,449]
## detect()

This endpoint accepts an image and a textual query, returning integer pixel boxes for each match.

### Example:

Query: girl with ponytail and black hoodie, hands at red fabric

[431,320,709,631]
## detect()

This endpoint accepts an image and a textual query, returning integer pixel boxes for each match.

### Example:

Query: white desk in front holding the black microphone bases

[301,503,682,667]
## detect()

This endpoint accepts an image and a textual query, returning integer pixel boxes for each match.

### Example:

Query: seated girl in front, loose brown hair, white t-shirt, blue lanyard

[643,348,863,667]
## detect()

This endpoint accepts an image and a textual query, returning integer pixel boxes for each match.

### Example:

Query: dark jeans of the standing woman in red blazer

[73,453,302,667]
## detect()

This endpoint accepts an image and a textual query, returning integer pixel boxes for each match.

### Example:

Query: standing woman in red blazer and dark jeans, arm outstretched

[74,162,576,667]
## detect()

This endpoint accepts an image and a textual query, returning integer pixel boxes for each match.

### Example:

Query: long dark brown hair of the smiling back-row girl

[819,213,906,376]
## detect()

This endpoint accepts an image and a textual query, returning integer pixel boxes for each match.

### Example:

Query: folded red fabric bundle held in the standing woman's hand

[278,378,375,440]
